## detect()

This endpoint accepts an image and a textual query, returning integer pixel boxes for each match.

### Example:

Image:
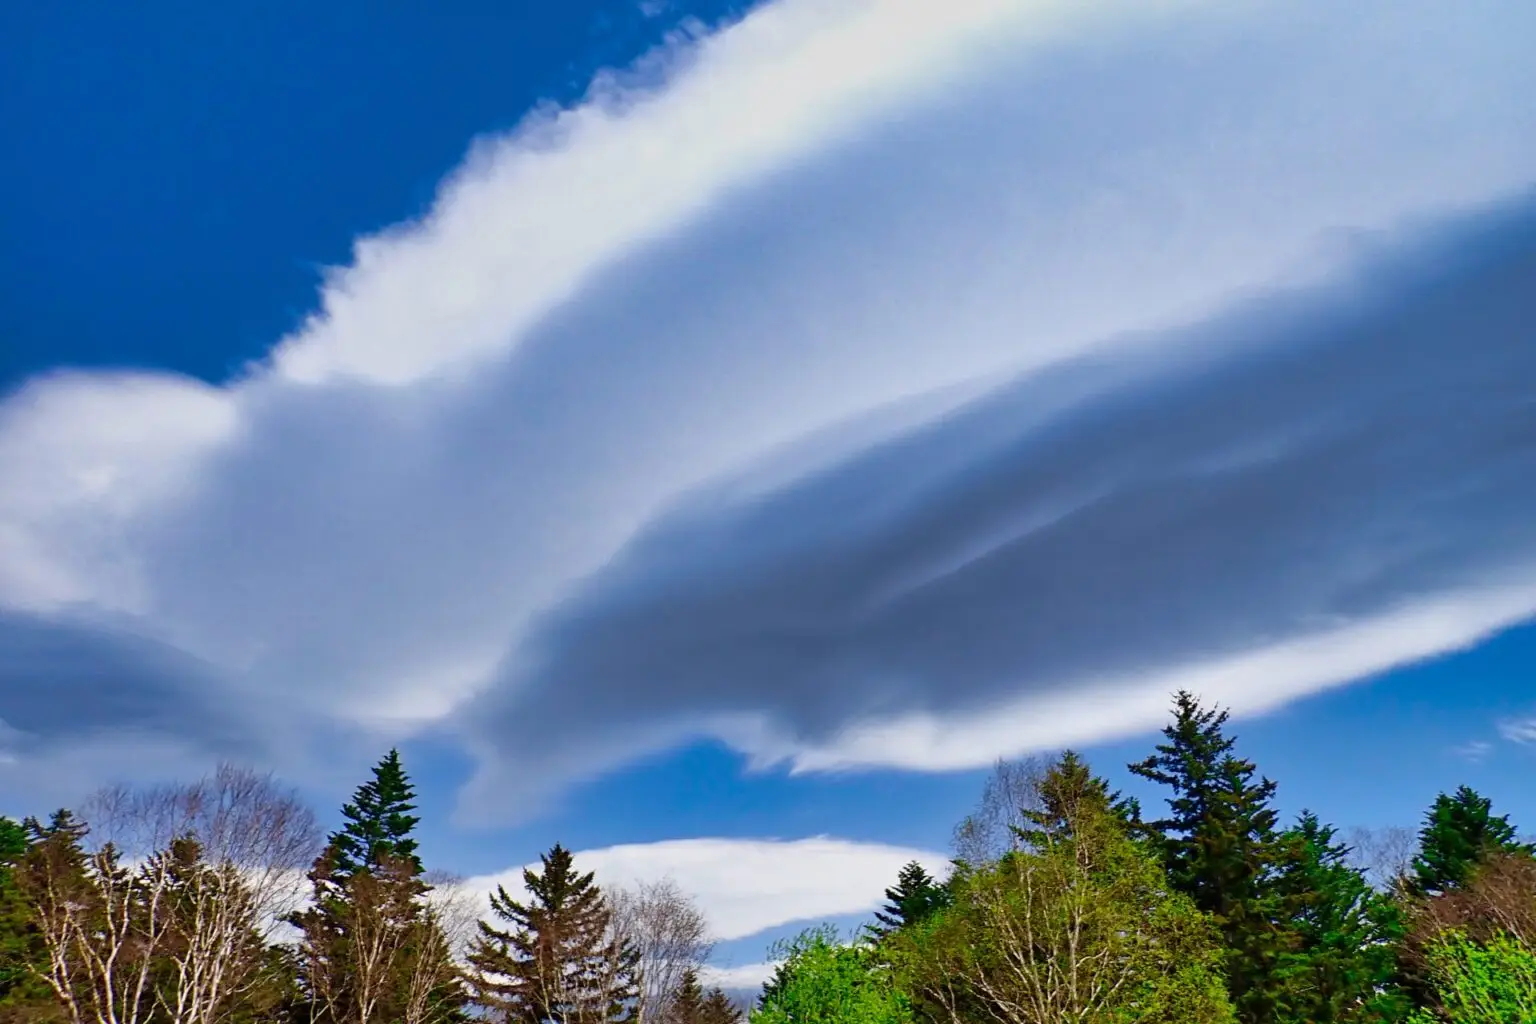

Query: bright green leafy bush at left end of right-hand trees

[750,926,912,1024]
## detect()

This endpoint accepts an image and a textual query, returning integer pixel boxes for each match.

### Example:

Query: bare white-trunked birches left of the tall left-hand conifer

[19,765,319,1024]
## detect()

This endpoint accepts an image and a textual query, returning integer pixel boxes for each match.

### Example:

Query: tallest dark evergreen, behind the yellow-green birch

[1129,691,1296,1024]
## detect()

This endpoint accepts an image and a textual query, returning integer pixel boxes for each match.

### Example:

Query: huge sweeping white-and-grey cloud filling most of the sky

[0,0,1536,818]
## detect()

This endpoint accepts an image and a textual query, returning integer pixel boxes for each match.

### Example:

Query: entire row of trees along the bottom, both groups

[0,694,1536,1024]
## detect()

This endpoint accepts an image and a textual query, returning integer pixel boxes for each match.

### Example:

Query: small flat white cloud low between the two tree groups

[464,837,949,939]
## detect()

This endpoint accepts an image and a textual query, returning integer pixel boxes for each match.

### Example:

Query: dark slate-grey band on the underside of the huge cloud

[464,194,1536,816]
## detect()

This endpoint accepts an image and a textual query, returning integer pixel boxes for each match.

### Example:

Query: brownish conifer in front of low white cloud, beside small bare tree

[468,844,639,1024]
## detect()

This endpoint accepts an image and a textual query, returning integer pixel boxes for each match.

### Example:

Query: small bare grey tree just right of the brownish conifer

[604,878,714,1024]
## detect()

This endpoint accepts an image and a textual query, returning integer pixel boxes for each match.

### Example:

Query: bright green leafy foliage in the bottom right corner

[1409,932,1536,1024]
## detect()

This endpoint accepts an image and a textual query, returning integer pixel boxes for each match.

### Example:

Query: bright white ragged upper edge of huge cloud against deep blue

[275,0,1183,384]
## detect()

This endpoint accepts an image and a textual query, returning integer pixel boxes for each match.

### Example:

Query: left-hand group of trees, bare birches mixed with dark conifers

[0,751,743,1024]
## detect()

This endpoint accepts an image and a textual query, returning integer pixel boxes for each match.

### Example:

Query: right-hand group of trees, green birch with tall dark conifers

[753,694,1536,1024]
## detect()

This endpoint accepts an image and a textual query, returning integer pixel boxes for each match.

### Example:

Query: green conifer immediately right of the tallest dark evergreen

[1275,811,1407,1024]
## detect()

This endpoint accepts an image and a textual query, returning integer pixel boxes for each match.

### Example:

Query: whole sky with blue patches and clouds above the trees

[0,0,1536,987]
